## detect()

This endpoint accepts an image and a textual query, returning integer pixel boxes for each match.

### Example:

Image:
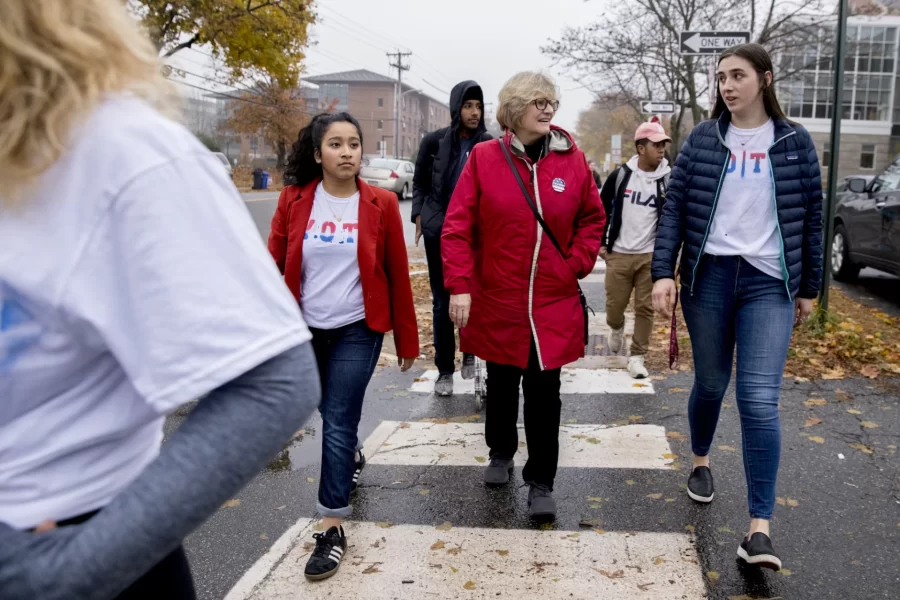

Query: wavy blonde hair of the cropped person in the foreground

[0,0,179,206]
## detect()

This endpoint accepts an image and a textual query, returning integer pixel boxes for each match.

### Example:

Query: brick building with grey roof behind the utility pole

[304,69,450,160]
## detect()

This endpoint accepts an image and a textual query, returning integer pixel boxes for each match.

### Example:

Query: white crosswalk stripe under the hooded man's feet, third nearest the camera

[409,369,654,395]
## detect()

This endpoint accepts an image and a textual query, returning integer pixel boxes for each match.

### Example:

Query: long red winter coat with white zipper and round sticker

[441,127,606,369]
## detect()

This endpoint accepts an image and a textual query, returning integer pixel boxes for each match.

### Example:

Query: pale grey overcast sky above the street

[173,0,607,130]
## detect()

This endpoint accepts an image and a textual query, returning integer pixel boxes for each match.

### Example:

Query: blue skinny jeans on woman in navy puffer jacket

[681,255,794,519]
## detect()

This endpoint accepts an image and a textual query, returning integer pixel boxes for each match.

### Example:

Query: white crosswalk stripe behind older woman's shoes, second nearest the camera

[363,420,675,470]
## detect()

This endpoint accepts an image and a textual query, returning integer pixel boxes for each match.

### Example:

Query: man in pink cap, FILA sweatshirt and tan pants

[600,117,672,379]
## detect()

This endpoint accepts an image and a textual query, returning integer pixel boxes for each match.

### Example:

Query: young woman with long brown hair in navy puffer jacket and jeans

[652,44,822,570]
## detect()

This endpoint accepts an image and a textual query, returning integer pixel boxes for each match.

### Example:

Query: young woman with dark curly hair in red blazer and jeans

[269,113,419,580]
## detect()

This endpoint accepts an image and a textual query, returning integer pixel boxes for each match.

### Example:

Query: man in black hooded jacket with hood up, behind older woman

[412,81,492,396]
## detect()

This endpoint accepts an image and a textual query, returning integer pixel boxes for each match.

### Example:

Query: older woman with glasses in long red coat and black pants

[442,72,606,520]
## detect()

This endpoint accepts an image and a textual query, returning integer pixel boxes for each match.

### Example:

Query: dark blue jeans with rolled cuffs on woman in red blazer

[310,321,384,518]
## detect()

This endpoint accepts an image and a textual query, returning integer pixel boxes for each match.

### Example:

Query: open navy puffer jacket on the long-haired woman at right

[652,112,822,299]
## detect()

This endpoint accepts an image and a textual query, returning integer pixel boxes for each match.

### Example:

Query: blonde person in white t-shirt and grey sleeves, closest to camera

[0,0,319,600]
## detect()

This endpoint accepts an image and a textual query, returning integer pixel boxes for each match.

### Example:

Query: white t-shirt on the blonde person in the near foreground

[0,97,310,529]
